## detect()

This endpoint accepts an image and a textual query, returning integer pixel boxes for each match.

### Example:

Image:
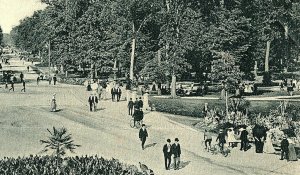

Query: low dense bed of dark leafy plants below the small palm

[0,155,142,175]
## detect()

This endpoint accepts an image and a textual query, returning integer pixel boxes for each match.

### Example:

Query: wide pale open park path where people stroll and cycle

[0,54,300,175]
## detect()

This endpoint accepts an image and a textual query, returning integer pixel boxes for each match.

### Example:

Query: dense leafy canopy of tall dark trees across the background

[11,0,300,82]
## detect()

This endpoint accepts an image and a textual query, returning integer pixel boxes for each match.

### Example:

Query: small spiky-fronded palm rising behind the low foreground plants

[40,127,80,167]
